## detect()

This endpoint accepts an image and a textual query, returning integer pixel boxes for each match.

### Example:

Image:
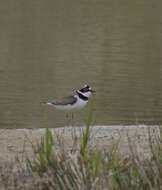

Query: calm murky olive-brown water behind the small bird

[0,0,162,128]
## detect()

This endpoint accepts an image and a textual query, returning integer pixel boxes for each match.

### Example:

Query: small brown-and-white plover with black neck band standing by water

[41,84,96,126]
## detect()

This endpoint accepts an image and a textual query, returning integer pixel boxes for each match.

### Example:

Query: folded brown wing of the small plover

[52,96,77,105]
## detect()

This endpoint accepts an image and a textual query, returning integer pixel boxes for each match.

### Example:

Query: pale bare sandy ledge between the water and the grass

[0,125,158,163]
